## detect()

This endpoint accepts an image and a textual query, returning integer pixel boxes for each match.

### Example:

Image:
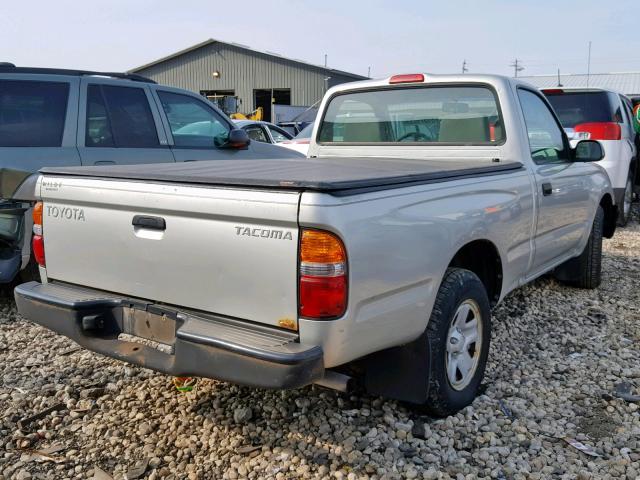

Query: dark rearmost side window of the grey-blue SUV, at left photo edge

[0,80,69,147]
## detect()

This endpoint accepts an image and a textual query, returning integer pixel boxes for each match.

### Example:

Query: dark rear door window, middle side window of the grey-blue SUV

[85,85,160,148]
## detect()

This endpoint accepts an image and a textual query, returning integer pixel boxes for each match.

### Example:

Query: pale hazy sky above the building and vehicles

[0,0,640,78]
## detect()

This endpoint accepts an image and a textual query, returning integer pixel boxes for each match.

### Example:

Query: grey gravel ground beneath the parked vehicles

[0,208,640,480]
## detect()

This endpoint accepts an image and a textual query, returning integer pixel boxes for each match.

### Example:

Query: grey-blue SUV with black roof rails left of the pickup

[0,64,304,284]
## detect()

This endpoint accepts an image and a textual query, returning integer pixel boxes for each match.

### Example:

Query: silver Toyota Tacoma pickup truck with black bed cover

[15,74,616,415]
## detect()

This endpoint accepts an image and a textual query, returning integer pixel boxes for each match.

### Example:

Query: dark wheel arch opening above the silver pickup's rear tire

[447,239,504,306]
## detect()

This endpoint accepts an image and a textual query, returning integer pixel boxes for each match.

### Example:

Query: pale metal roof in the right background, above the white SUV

[518,72,640,96]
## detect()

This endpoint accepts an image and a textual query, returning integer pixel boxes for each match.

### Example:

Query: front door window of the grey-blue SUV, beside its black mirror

[158,91,229,148]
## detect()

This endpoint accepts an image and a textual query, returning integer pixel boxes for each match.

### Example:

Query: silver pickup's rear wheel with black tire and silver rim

[424,268,491,417]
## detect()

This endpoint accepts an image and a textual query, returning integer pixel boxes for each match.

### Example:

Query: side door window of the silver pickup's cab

[518,89,569,163]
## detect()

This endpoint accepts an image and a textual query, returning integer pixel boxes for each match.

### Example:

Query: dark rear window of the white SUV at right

[547,92,622,128]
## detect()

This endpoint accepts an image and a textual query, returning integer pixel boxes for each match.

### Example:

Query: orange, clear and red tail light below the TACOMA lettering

[299,229,347,319]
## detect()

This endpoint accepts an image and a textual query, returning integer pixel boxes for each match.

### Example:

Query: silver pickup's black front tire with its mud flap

[555,206,604,289]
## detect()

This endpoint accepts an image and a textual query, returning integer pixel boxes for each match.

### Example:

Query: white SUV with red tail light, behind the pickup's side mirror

[543,88,638,226]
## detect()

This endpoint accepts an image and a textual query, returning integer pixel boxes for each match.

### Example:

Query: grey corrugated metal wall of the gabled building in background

[136,42,354,111]
